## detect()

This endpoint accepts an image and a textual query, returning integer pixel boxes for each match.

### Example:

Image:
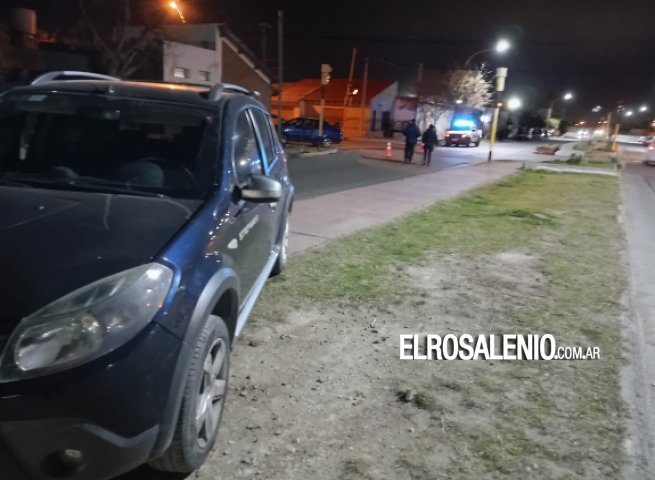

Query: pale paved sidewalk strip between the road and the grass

[289,162,521,253]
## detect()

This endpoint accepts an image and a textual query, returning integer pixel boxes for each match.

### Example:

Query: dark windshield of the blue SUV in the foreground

[0,92,216,198]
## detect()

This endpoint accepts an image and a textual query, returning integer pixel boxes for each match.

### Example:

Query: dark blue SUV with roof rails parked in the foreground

[0,72,294,480]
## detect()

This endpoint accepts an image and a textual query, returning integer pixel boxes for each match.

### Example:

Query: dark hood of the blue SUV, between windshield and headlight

[0,187,200,334]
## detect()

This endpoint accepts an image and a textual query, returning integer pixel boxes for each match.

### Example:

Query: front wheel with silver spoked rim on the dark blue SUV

[150,315,230,473]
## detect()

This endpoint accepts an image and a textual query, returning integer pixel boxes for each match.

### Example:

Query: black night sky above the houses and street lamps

[11,0,655,124]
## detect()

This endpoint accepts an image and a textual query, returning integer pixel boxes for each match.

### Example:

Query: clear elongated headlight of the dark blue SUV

[0,263,173,382]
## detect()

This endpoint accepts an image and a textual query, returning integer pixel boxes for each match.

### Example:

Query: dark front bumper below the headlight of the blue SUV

[0,323,182,480]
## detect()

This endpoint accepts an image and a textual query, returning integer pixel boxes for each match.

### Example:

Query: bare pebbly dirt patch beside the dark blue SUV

[196,251,620,480]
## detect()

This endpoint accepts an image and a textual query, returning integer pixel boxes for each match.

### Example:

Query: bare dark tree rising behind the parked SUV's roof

[78,0,163,78]
